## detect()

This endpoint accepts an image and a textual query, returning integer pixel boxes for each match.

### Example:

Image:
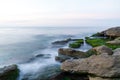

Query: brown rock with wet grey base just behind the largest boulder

[55,48,86,62]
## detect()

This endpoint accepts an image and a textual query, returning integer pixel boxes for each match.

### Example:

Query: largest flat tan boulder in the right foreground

[61,53,120,78]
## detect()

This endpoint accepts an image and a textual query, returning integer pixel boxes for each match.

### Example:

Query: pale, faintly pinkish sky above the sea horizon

[0,0,120,27]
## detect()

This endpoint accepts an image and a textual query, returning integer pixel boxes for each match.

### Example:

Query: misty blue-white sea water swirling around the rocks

[0,27,107,80]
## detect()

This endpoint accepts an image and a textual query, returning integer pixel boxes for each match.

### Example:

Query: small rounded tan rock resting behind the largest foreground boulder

[93,45,113,55]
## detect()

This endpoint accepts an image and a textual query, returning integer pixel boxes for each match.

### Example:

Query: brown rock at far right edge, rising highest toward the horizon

[101,27,120,37]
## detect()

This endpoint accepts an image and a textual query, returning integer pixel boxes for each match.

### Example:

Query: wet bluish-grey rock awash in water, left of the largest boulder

[22,64,61,80]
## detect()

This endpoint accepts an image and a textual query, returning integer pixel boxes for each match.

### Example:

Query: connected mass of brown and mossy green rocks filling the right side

[57,27,120,80]
